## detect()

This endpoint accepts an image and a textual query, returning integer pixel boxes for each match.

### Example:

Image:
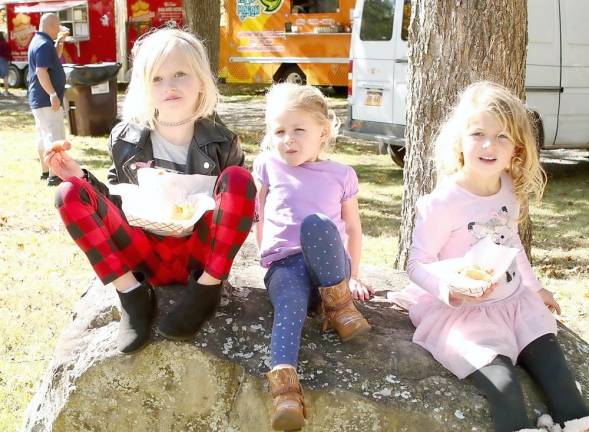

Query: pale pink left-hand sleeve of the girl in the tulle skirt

[407,196,452,306]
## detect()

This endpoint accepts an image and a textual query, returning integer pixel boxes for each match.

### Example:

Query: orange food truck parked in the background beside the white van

[219,0,355,90]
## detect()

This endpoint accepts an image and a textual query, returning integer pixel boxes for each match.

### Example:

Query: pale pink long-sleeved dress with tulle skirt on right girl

[393,174,556,378]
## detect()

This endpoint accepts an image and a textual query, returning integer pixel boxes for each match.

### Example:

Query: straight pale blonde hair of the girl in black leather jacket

[123,28,218,129]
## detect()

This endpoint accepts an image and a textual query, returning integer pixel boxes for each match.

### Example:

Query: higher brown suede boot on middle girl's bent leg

[319,279,370,342]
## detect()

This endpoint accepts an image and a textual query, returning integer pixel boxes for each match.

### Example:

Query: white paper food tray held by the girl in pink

[425,237,519,297]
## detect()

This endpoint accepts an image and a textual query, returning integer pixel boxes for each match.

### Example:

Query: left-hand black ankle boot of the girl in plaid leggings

[117,281,155,354]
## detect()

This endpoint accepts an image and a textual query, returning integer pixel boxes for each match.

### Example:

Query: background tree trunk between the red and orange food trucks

[184,0,221,77]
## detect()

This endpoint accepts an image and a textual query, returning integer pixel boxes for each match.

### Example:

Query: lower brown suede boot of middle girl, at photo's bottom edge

[266,367,307,431]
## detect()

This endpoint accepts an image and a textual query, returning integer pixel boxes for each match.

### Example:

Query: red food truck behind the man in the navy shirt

[0,0,184,87]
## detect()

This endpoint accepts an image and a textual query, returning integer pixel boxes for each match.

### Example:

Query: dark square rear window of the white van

[360,0,395,41]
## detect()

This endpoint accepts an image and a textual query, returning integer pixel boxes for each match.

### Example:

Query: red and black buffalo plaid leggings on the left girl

[55,166,256,285]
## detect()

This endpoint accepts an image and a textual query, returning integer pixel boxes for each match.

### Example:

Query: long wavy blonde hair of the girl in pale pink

[434,81,546,220]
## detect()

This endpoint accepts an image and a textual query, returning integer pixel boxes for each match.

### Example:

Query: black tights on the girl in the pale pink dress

[469,334,589,432]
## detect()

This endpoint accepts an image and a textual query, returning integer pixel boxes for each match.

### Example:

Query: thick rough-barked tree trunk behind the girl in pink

[396,0,527,269]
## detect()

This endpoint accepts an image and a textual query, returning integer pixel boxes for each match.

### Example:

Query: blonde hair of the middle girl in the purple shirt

[262,83,341,150]
